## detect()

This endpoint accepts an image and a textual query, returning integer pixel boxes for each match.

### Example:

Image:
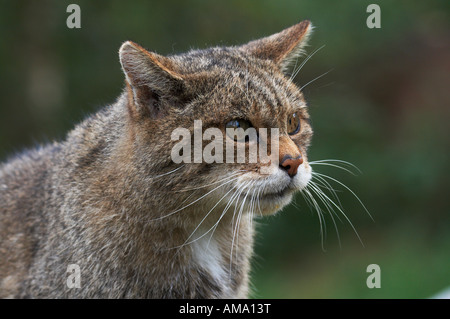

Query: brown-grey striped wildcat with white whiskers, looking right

[0,21,312,298]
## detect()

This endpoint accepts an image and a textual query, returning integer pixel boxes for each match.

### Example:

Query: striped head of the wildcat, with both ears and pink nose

[119,21,312,220]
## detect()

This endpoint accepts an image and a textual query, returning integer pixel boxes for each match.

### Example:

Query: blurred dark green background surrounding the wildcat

[0,0,450,298]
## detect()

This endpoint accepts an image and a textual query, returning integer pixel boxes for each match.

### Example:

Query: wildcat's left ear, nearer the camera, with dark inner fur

[119,41,183,117]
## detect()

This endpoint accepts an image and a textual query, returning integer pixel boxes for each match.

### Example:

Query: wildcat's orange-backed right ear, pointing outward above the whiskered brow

[241,20,313,71]
